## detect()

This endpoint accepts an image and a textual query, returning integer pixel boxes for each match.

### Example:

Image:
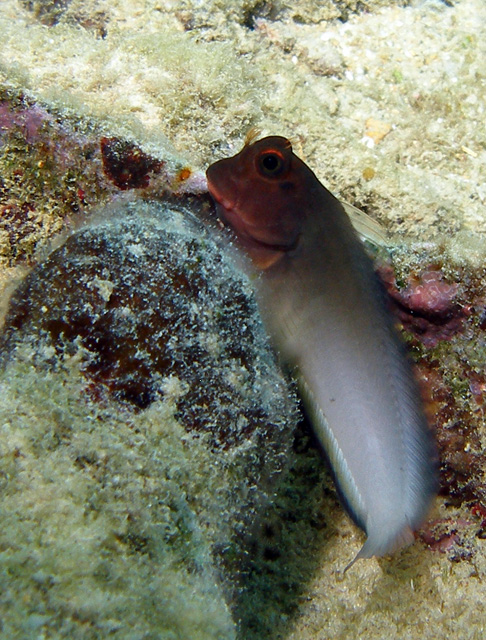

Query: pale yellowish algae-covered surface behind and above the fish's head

[0,0,485,244]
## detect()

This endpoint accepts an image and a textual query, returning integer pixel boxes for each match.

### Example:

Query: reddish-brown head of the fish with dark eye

[206,136,317,268]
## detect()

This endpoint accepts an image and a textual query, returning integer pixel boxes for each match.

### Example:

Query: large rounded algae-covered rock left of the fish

[0,200,296,640]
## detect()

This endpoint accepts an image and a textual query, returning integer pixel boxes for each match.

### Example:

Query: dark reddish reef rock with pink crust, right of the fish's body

[381,246,486,561]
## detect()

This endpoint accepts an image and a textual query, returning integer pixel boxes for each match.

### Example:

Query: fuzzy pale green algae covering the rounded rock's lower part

[0,361,234,639]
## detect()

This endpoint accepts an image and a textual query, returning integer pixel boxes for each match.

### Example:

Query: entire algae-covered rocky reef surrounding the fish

[0,0,486,640]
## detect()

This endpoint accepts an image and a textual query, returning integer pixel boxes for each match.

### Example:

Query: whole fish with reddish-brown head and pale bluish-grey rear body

[206,136,438,569]
